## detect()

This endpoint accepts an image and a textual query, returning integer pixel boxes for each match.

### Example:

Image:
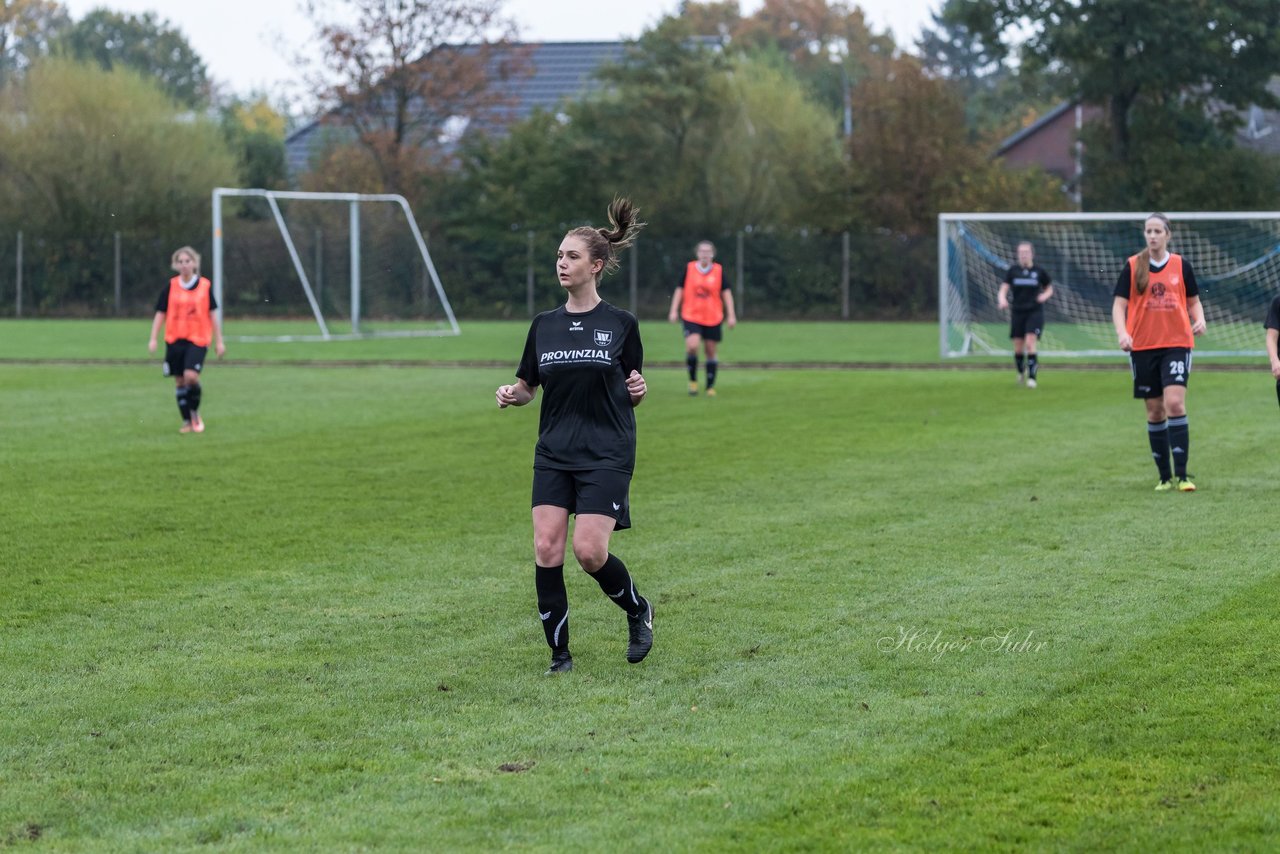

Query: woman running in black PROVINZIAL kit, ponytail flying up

[497,198,653,673]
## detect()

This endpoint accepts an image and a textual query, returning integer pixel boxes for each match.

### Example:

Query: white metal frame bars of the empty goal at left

[211,187,461,341]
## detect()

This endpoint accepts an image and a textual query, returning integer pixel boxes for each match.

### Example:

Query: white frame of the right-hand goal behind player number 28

[938,211,1280,360]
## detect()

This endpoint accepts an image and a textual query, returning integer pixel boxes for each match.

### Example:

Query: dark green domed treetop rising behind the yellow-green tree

[58,9,209,108]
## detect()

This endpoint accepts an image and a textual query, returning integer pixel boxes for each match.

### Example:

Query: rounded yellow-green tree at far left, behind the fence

[0,59,236,310]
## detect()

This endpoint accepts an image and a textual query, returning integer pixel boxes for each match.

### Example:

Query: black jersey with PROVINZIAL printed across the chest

[516,302,644,474]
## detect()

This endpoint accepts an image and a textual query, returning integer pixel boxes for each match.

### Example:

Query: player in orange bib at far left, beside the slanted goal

[147,246,227,433]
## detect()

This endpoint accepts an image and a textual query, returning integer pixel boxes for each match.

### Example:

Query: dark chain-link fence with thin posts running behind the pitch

[0,222,937,320]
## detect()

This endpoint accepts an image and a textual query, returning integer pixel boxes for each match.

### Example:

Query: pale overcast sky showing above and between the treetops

[61,0,942,101]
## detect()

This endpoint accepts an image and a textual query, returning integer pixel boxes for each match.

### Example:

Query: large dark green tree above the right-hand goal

[956,0,1280,207]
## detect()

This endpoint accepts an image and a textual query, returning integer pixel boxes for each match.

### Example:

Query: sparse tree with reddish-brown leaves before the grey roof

[296,0,522,197]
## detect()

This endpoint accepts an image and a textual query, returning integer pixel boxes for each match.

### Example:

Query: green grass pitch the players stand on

[0,320,1280,851]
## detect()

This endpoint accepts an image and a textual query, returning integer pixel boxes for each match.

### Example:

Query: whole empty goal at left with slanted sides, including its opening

[211,187,460,341]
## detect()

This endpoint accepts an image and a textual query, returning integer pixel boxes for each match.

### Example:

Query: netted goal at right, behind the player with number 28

[938,217,1280,359]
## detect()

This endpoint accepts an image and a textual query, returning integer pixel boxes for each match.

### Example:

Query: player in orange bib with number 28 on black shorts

[1111,214,1204,492]
